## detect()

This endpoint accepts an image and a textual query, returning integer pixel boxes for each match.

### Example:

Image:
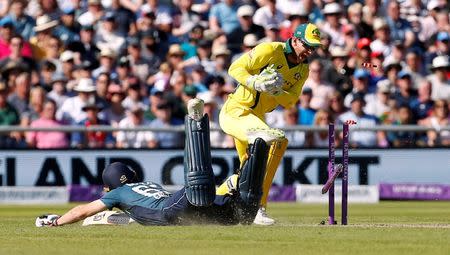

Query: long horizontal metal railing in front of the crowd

[0,125,450,134]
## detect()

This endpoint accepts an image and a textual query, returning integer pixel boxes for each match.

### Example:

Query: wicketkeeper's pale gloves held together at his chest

[247,65,283,95]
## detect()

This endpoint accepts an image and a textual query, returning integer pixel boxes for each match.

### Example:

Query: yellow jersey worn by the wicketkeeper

[228,42,309,118]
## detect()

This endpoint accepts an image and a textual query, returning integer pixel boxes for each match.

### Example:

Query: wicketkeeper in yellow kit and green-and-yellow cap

[218,23,320,225]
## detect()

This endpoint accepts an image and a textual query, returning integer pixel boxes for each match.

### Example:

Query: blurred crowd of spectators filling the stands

[0,0,450,149]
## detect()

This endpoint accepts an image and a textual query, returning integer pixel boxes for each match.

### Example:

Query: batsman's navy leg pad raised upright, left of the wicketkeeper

[184,114,216,206]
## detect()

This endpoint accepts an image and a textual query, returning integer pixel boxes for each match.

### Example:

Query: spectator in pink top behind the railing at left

[26,100,69,149]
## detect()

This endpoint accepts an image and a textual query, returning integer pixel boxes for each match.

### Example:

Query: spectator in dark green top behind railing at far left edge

[0,82,19,148]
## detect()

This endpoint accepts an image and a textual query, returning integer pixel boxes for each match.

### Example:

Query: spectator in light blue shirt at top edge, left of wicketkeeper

[209,0,239,35]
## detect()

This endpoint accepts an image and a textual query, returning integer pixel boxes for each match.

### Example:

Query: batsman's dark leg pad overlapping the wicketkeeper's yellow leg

[237,138,269,224]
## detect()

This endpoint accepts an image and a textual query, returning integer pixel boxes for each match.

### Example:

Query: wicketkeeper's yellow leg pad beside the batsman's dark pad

[261,138,288,207]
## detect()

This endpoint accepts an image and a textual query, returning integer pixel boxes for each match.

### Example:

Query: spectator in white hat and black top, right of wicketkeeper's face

[324,47,352,96]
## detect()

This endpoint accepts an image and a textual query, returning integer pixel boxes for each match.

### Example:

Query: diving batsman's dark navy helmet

[102,162,136,191]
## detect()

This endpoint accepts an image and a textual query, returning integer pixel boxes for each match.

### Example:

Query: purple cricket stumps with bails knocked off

[322,123,349,225]
